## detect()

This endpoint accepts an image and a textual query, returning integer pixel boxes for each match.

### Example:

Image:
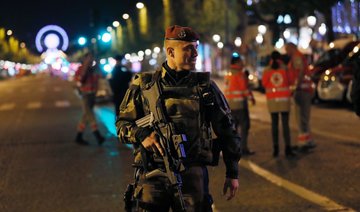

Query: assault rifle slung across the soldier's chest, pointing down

[136,80,187,211]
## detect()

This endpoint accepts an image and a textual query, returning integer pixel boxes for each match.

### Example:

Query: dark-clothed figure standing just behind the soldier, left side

[109,55,132,120]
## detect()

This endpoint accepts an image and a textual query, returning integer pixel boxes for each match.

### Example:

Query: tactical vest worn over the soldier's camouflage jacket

[140,71,215,165]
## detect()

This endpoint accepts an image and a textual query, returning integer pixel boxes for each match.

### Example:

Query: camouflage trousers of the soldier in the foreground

[132,166,213,212]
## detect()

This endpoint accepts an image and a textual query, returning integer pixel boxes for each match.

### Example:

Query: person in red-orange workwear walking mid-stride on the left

[75,52,105,145]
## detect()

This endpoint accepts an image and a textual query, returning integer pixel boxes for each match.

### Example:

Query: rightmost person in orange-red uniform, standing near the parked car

[285,43,316,151]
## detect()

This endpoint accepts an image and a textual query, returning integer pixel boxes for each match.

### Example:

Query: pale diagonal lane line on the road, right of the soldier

[239,159,355,212]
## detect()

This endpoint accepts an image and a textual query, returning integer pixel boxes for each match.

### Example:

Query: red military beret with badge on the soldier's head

[165,25,199,42]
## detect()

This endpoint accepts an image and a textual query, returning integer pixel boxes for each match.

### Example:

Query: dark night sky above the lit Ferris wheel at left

[0,0,137,52]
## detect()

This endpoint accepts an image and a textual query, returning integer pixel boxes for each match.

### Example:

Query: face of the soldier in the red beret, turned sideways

[173,41,198,71]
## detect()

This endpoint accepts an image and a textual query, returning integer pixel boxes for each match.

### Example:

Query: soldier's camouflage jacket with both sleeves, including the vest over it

[116,63,241,179]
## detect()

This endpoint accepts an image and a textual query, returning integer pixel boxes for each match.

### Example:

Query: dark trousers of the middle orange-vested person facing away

[271,112,290,146]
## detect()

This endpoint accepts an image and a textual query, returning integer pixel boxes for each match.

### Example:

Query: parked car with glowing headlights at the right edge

[316,44,360,102]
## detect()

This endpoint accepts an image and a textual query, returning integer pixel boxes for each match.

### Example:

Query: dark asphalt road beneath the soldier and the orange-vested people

[0,76,360,212]
